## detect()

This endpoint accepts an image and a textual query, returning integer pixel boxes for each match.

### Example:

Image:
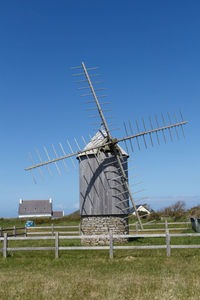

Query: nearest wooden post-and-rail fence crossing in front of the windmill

[0,229,200,258]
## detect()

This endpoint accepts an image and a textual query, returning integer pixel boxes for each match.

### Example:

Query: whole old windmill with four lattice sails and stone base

[25,62,188,244]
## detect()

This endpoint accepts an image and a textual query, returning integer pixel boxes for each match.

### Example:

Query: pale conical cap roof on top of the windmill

[78,129,129,157]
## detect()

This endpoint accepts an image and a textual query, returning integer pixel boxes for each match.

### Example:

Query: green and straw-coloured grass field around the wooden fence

[0,218,200,300]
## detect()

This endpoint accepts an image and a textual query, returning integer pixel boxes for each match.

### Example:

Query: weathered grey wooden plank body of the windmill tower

[79,152,129,216]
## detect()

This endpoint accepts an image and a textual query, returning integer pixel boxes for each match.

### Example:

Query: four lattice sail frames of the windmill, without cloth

[25,62,188,229]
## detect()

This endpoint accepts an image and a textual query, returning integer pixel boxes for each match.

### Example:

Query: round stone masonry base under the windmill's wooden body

[81,215,129,246]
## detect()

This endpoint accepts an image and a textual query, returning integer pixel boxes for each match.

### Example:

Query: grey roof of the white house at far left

[18,199,52,215]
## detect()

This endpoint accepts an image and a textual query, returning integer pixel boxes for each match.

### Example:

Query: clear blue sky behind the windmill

[0,0,200,217]
